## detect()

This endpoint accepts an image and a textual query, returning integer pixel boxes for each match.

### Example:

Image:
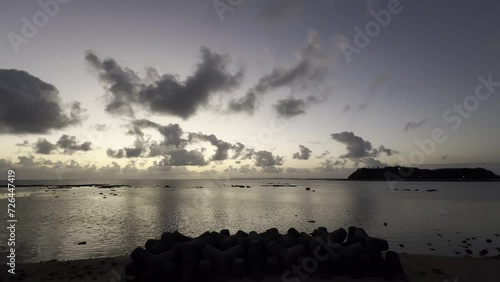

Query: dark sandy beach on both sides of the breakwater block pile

[0,254,500,282]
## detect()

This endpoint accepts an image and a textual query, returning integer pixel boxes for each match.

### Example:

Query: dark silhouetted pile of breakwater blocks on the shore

[126,226,404,281]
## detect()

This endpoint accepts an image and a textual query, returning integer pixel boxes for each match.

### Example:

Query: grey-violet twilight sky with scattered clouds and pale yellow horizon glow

[0,0,500,179]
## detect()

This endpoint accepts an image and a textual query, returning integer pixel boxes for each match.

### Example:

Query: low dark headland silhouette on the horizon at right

[347,166,500,181]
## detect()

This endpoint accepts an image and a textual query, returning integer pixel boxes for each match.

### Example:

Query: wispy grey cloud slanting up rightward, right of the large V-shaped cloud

[229,31,332,114]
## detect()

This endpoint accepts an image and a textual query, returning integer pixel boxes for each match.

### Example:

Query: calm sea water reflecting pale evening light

[0,180,500,262]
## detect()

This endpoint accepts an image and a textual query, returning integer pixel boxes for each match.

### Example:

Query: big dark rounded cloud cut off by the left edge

[0,69,84,134]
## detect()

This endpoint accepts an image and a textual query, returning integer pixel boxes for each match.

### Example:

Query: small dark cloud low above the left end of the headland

[331,131,397,159]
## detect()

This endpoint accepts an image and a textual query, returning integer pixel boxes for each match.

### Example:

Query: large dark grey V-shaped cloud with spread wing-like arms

[85,46,243,119]
